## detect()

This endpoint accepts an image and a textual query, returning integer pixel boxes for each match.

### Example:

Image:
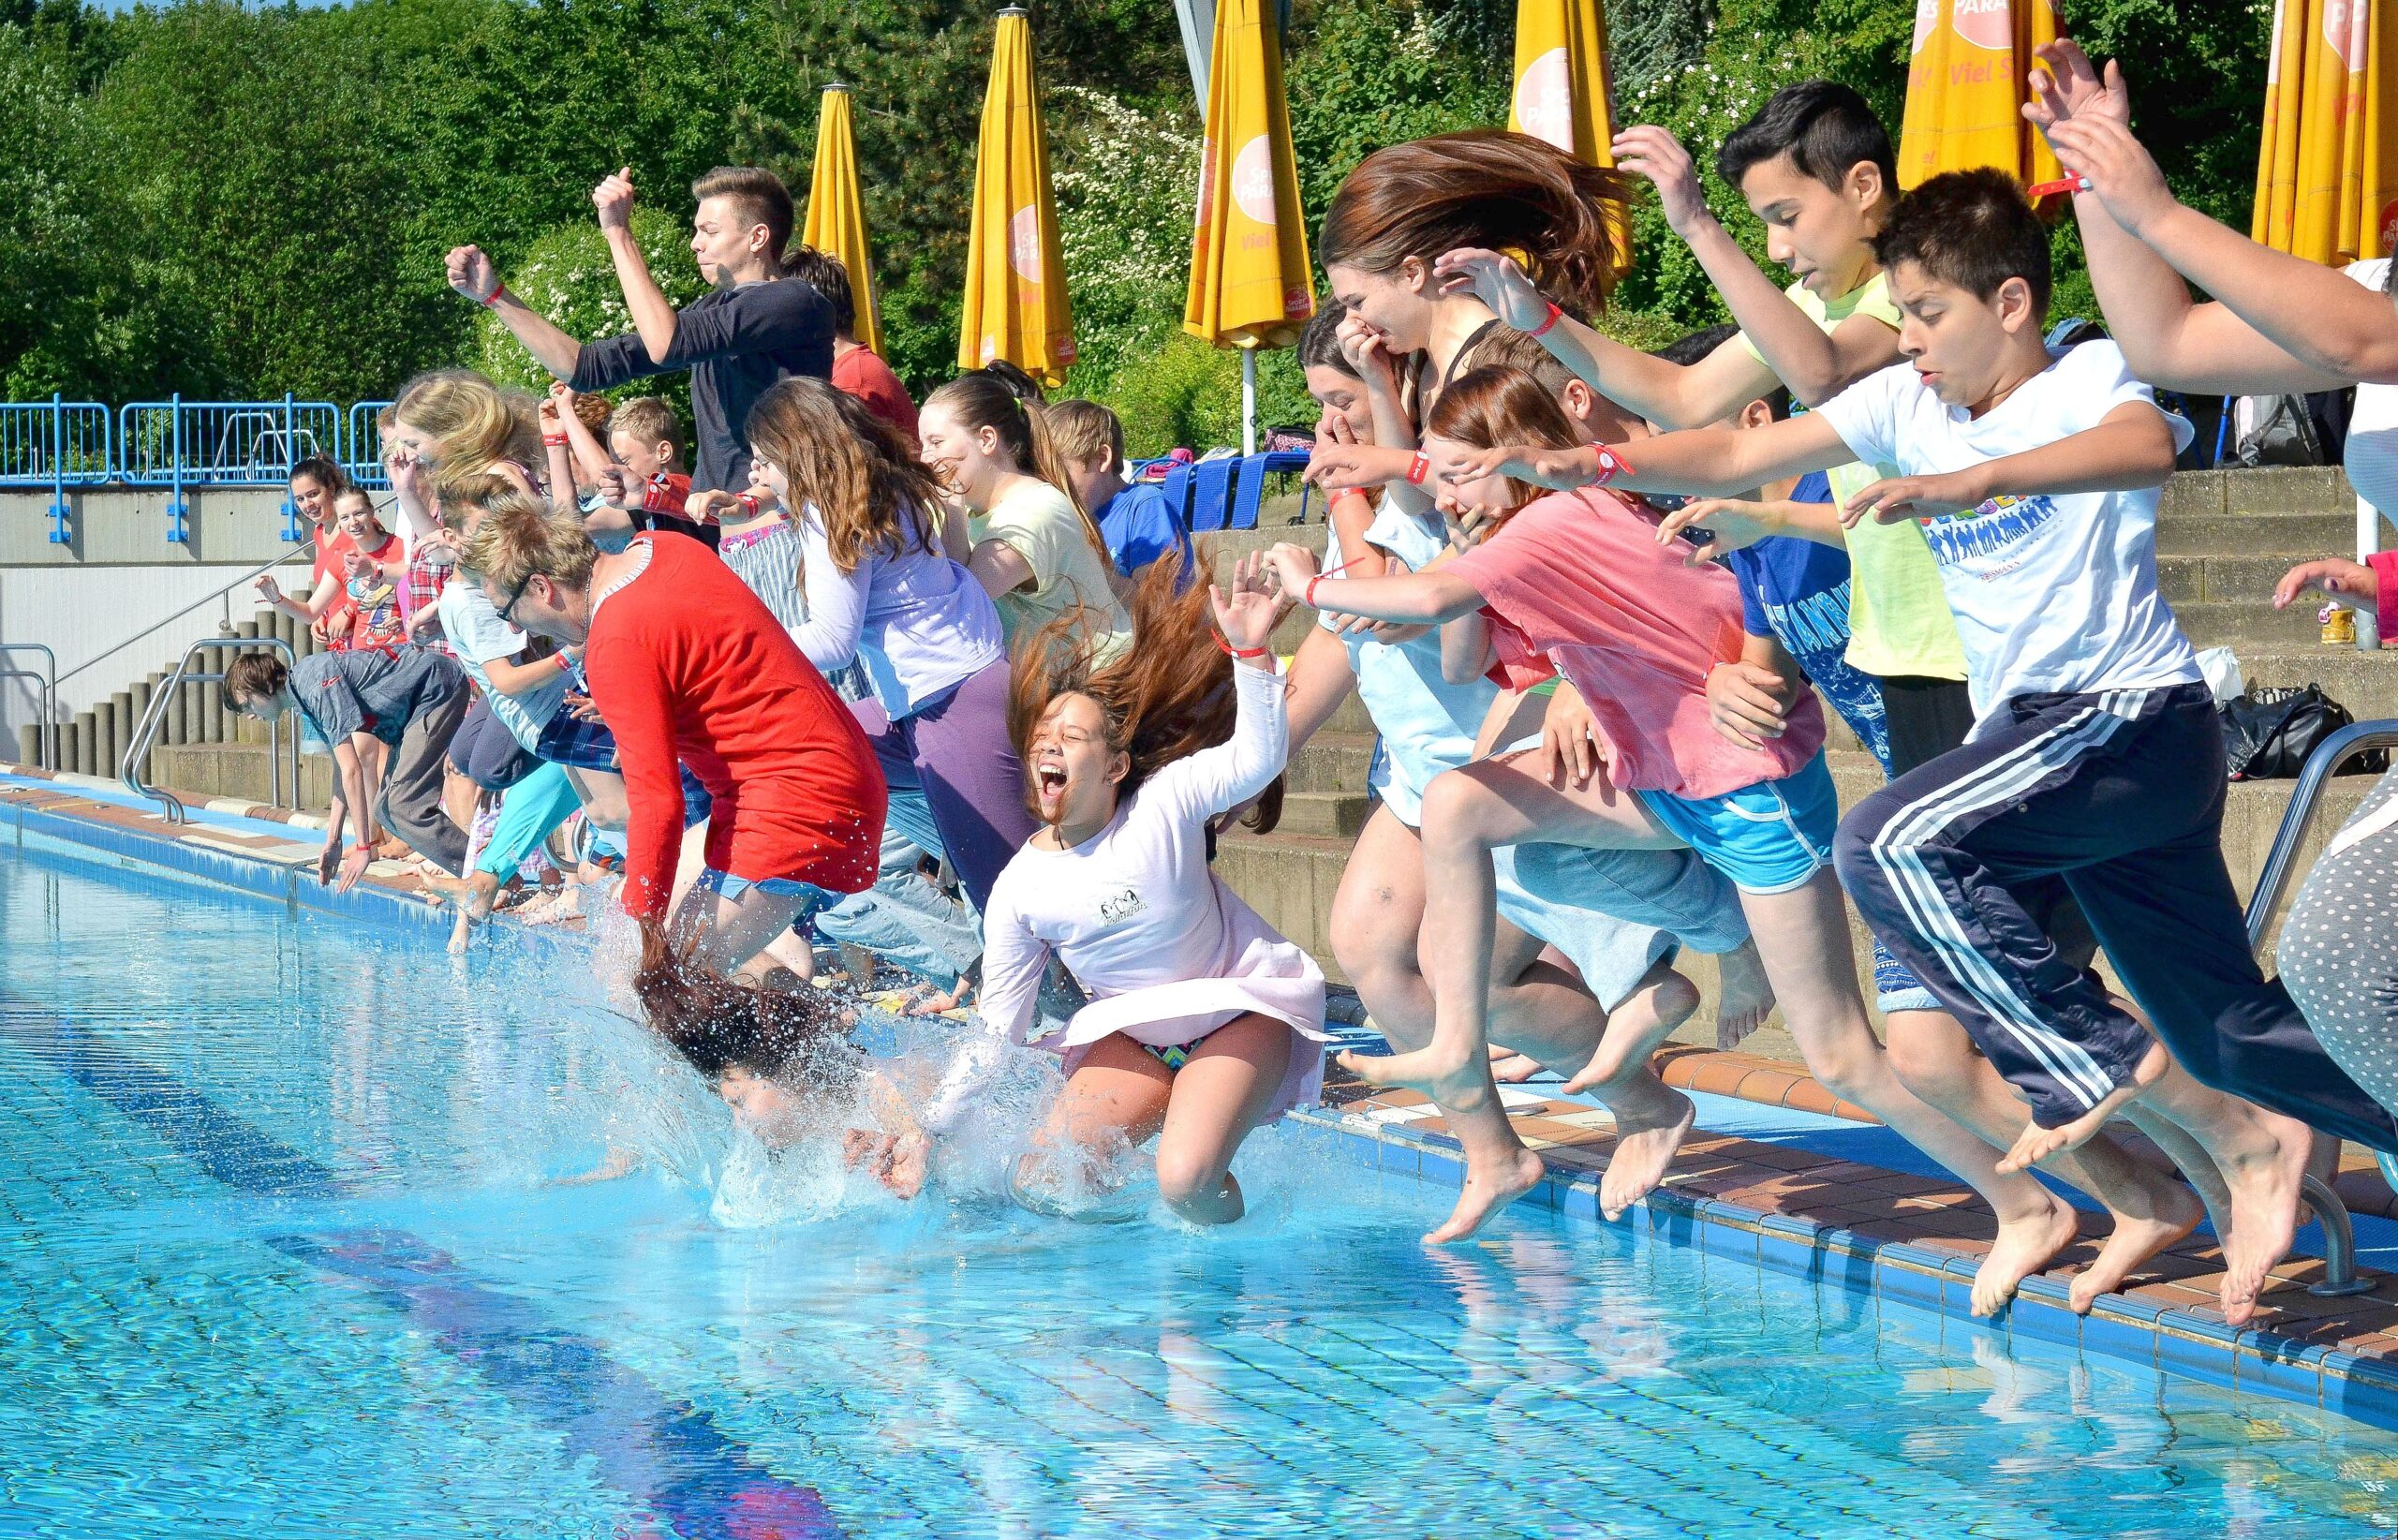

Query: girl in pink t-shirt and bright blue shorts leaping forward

[1271,369,2081,1242]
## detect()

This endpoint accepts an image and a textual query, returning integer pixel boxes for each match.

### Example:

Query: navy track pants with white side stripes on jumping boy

[1834,684,2398,1149]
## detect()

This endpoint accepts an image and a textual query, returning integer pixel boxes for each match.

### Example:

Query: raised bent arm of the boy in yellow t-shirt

[1614,127,1900,403]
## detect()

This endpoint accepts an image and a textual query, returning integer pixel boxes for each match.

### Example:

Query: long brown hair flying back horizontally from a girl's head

[1316,129,1633,317]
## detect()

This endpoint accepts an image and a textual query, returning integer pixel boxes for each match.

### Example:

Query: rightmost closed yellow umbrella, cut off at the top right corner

[2249,0,2398,264]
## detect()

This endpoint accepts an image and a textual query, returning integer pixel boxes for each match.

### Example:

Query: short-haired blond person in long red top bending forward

[461,509,887,983]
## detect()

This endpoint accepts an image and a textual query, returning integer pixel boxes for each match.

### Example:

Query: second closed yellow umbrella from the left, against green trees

[956,5,1074,386]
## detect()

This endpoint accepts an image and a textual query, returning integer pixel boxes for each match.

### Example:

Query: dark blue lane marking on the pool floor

[0,996,842,1540]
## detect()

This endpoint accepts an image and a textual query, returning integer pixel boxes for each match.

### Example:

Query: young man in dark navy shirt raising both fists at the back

[449,166,832,515]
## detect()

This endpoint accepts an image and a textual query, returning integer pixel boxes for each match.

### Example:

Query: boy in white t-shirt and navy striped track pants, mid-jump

[1460,170,2398,1325]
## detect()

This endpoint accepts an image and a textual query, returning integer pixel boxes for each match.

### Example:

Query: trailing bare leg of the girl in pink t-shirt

[1741,871,2077,1314]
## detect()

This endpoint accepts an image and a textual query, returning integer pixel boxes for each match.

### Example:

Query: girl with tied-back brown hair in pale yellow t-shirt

[916,369,1132,653]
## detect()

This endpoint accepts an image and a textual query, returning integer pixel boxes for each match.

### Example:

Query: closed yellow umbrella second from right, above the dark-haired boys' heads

[1900,0,2057,187]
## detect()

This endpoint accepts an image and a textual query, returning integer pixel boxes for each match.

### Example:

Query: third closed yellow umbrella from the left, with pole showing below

[1182,0,1316,453]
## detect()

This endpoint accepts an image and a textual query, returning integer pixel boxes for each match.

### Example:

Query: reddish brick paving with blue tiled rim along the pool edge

[14,765,2398,1428]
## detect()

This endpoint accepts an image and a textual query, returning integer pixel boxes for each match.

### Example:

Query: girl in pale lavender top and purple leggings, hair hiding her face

[748,379,1033,907]
